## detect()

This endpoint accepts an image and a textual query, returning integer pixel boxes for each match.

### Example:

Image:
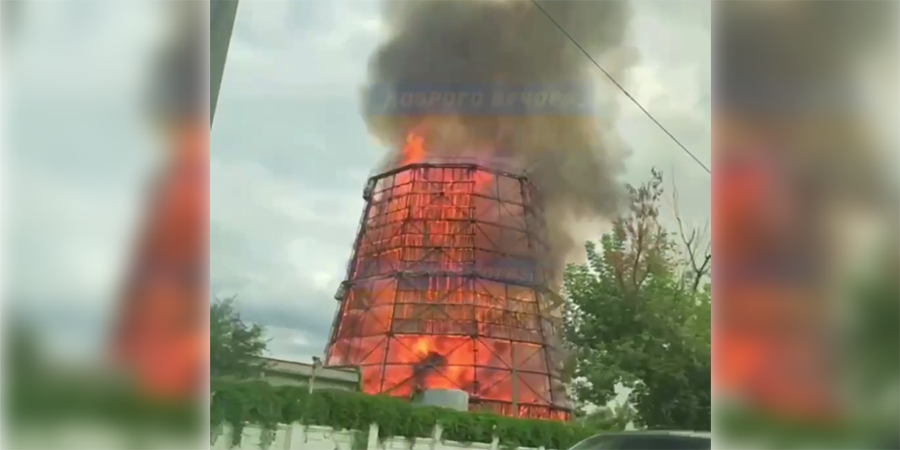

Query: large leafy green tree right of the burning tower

[564,170,711,430]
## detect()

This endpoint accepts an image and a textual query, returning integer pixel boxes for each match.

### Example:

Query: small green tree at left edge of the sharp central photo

[209,298,268,378]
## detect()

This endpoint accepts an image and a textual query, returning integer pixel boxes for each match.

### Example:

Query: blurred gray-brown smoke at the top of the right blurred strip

[713,0,900,187]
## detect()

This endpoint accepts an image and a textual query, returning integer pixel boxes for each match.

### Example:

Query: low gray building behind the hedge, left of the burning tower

[262,358,362,391]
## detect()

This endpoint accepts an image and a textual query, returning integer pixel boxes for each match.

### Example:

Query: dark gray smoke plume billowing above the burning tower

[367,0,637,274]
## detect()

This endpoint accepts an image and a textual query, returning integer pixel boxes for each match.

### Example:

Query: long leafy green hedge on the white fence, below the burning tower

[210,382,596,449]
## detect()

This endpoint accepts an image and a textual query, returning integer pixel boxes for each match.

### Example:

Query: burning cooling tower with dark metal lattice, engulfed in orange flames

[326,163,569,420]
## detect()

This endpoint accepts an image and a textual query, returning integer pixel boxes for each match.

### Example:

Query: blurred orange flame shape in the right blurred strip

[713,152,836,419]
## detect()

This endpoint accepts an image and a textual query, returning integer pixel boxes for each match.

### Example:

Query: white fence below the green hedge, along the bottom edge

[210,424,554,450]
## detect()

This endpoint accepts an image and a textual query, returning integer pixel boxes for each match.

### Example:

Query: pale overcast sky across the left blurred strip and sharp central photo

[4,0,710,360]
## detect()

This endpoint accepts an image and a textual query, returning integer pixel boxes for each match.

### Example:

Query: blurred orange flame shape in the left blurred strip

[114,122,209,399]
